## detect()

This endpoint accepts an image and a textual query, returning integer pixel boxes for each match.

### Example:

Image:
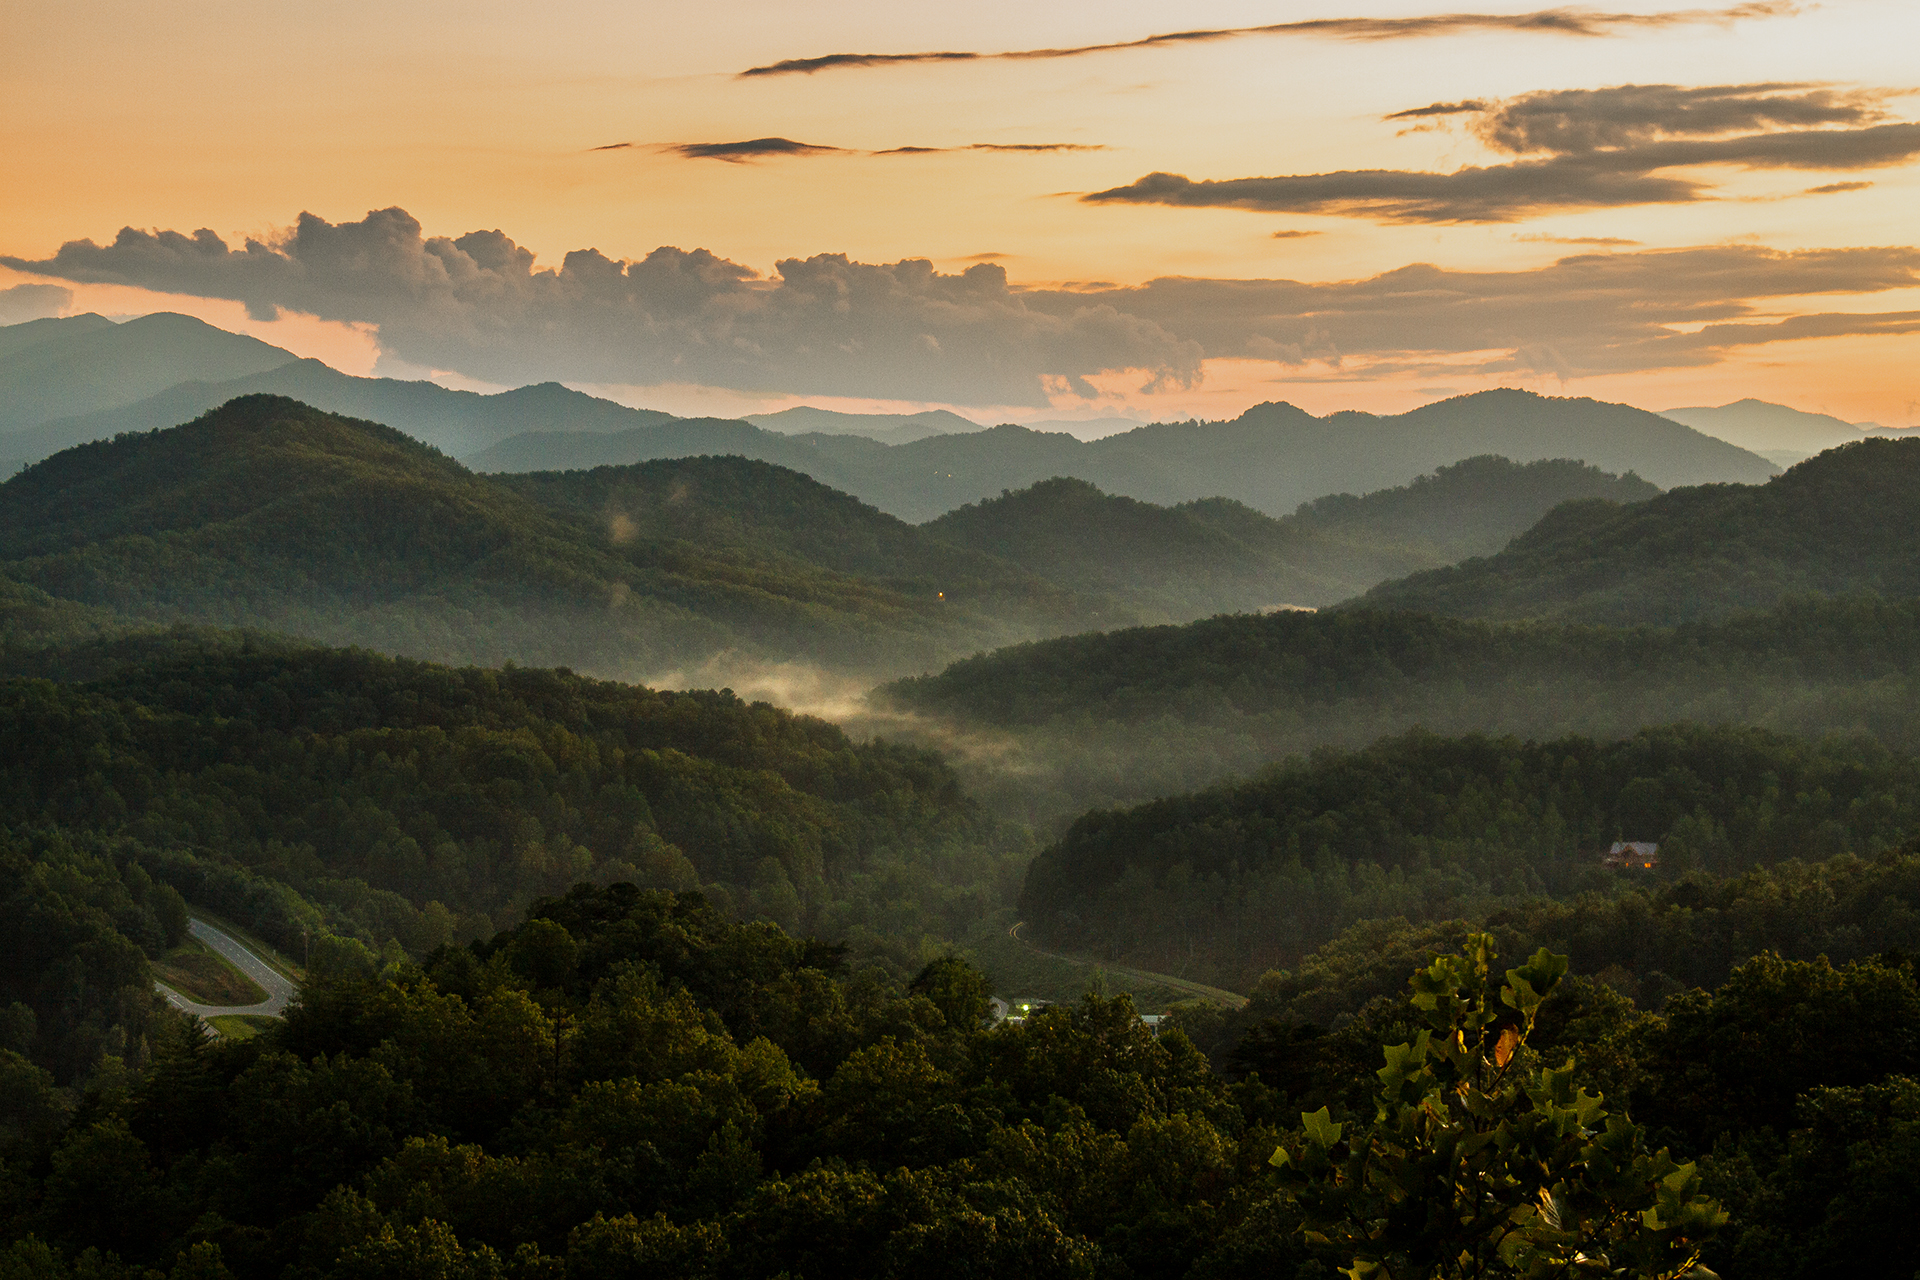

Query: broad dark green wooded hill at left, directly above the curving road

[0,635,1029,1079]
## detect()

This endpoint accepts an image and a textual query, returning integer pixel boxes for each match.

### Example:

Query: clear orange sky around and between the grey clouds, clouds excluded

[0,0,1920,424]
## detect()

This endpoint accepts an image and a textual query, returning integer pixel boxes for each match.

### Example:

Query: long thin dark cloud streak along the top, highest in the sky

[739,0,1799,79]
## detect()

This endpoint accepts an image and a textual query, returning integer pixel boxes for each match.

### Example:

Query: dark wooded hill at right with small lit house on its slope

[1020,725,1920,986]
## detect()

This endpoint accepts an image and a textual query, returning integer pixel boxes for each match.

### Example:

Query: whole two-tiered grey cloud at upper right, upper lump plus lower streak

[1081,84,1920,223]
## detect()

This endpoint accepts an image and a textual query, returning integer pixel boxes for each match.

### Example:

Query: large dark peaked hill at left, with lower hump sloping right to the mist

[0,395,1105,674]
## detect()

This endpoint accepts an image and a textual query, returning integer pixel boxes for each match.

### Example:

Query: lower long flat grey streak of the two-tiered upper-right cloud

[1081,123,1920,223]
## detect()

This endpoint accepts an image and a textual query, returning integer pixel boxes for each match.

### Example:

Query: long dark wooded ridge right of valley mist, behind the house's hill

[876,599,1920,819]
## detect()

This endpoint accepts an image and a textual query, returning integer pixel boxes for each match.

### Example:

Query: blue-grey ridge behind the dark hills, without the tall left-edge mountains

[468,391,1776,522]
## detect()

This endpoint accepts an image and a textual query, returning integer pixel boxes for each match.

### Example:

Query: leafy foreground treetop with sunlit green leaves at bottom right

[1273,935,1726,1280]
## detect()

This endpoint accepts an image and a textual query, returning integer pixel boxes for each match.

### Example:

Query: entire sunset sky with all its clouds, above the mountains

[0,0,1920,426]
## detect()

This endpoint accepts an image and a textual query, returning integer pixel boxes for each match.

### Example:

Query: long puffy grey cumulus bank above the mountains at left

[0,209,1200,407]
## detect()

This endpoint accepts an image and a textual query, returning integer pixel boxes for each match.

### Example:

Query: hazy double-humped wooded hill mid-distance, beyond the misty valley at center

[922,457,1659,622]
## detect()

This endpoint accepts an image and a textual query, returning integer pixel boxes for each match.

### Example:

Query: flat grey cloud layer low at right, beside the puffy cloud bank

[1027,246,1920,376]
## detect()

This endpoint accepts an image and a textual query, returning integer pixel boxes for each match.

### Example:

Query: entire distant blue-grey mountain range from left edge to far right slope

[0,313,1776,522]
